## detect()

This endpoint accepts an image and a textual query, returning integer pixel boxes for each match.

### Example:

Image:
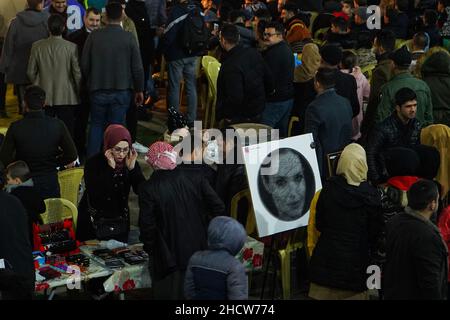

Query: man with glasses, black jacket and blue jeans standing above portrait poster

[262,22,295,137]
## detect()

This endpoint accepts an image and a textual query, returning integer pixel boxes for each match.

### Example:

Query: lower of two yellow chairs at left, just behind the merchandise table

[41,198,78,231]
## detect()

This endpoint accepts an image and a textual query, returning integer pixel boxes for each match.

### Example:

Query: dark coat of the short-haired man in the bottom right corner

[381,207,448,300]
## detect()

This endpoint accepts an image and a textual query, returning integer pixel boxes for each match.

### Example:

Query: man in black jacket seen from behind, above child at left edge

[0,86,77,199]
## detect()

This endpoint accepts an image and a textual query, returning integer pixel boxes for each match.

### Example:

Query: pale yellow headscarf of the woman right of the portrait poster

[336,143,368,187]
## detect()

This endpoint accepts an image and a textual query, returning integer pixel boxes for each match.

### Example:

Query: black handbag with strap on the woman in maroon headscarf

[86,193,128,240]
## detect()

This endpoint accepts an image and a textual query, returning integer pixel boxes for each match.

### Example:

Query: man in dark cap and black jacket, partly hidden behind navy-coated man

[320,44,360,117]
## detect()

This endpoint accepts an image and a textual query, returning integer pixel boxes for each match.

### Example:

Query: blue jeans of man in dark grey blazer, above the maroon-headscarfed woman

[87,90,131,157]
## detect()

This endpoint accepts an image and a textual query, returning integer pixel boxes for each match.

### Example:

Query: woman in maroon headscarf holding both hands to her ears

[76,124,145,243]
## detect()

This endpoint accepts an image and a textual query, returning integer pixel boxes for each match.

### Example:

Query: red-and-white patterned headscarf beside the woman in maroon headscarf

[145,141,177,170]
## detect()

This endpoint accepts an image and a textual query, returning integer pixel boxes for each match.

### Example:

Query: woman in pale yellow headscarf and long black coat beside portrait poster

[309,143,381,300]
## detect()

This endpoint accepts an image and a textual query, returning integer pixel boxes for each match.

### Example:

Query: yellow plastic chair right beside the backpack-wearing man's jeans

[202,57,220,128]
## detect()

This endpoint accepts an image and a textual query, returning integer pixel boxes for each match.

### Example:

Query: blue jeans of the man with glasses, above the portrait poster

[261,99,294,137]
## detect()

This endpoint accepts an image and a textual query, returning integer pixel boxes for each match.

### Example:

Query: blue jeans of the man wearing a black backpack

[167,57,198,124]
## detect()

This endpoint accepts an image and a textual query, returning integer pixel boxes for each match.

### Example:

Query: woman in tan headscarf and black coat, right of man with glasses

[292,43,321,135]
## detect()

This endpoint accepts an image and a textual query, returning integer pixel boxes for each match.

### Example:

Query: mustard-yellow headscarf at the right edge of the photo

[420,124,450,199]
